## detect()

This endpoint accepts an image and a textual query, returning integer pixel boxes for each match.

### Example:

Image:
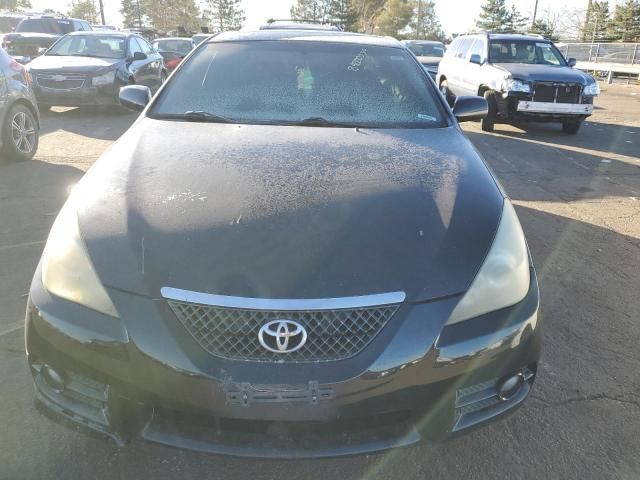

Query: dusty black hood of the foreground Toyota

[74,118,503,301]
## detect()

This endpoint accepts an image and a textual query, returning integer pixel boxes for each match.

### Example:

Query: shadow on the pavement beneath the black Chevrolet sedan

[40,107,138,140]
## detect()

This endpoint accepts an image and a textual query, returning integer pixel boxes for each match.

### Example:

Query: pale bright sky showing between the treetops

[31,0,620,33]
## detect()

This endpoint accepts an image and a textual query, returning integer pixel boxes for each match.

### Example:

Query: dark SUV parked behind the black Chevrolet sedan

[2,16,91,63]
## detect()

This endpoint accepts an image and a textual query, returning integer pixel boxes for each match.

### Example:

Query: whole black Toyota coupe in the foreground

[26,30,540,458]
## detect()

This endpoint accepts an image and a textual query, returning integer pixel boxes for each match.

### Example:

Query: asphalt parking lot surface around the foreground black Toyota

[0,85,640,480]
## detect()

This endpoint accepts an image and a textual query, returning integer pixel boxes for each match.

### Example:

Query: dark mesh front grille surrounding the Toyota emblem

[168,300,399,362]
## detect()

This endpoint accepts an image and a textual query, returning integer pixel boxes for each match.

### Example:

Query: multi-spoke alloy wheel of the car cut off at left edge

[2,104,39,160]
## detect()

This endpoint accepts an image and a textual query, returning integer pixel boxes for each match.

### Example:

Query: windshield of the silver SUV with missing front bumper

[489,40,567,67]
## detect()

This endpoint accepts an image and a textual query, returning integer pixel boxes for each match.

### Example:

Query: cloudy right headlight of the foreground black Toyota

[447,200,530,325]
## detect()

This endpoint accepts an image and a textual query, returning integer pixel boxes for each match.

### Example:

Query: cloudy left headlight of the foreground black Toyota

[42,202,118,318]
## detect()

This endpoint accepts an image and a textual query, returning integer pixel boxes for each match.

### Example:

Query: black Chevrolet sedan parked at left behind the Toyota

[29,31,167,107]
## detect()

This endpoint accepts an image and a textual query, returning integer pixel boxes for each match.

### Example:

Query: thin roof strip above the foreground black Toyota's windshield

[208,29,406,48]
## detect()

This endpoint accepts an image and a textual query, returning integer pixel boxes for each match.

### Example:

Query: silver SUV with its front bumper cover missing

[436,33,600,134]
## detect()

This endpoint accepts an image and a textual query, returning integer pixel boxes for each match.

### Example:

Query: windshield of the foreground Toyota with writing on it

[150,41,446,128]
